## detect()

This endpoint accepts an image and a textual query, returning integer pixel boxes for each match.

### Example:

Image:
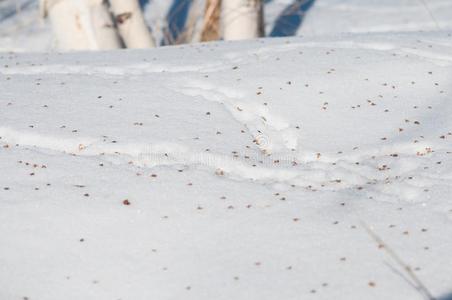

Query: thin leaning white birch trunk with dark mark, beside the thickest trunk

[110,0,155,48]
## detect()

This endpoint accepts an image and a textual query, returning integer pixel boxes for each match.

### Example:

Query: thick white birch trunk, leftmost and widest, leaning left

[40,0,122,50]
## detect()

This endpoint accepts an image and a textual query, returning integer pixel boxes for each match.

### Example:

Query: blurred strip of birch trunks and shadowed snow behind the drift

[0,0,452,51]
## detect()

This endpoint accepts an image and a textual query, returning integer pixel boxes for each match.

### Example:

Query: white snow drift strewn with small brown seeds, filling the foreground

[0,0,452,300]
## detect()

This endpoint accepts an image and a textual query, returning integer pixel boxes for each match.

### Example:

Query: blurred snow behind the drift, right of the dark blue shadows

[299,0,452,36]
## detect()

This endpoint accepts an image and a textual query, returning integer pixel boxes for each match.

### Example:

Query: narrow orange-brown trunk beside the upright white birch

[201,0,222,42]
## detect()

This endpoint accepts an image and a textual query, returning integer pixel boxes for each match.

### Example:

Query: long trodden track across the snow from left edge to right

[0,128,446,201]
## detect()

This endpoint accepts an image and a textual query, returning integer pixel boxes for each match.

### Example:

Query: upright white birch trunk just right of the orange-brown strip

[221,0,264,40]
